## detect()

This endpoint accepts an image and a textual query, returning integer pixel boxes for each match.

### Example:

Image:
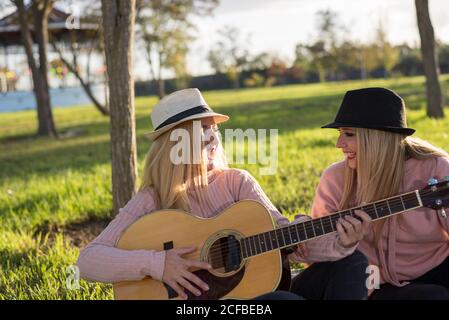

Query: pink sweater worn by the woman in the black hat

[312,158,449,286]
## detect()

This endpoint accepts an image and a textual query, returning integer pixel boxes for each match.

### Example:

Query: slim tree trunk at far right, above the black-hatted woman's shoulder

[415,0,444,118]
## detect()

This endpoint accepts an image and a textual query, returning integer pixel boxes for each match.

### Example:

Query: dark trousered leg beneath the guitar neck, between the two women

[291,251,368,300]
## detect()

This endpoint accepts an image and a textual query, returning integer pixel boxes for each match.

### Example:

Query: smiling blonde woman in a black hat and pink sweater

[304,88,449,299]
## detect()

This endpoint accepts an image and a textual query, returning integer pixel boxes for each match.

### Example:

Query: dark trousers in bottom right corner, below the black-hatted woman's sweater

[370,257,449,300]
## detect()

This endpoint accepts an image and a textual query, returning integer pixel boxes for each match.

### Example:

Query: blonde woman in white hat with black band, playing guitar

[77,89,364,299]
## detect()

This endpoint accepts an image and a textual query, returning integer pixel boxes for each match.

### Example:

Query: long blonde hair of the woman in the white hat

[140,120,227,211]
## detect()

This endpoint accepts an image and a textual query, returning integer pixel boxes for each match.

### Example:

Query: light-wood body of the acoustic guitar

[114,200,290,300]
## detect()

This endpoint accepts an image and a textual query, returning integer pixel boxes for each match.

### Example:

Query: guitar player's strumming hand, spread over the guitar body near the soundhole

[162,247,211,299]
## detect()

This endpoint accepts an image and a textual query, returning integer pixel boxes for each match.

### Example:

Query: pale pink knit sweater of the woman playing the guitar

[77,169,356,283]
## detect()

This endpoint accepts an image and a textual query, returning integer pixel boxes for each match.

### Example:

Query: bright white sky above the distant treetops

[178,0,449,75]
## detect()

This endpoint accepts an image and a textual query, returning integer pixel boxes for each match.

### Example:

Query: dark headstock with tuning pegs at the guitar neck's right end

[419,175,449,210]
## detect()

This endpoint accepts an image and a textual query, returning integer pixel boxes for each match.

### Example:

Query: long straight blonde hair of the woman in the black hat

[340,128,449,245]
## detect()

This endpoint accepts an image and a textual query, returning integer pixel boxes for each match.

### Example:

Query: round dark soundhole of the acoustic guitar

[208,235,242,274]
